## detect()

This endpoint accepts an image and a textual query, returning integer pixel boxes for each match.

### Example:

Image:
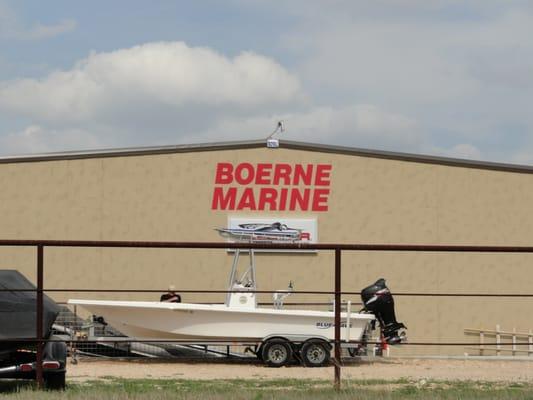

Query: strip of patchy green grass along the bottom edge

[0,378,533,400]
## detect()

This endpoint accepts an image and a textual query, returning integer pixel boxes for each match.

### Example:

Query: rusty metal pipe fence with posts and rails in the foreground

[0,240,533,389]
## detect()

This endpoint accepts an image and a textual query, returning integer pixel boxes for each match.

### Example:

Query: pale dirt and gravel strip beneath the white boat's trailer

[67,360,533,382]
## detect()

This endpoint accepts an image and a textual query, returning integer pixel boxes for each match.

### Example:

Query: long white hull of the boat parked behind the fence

[69,300,374,341]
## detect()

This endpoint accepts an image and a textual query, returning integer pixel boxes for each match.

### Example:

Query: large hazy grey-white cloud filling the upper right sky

[283,0,533,141]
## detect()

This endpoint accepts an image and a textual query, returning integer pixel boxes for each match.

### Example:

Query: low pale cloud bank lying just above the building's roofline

[0,105,420,155]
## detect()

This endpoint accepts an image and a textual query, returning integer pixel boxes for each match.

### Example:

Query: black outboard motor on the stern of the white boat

[361,278,407,344]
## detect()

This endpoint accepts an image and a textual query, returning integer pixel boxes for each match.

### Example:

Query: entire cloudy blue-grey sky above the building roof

[0,0,533,164]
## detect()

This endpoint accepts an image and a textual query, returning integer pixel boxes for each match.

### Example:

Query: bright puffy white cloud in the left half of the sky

[0,42,303,123]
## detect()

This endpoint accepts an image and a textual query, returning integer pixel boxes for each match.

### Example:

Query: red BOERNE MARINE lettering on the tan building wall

[211,162,332,212]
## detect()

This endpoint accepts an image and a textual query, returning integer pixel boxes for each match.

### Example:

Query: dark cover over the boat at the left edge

[0,269,59,340]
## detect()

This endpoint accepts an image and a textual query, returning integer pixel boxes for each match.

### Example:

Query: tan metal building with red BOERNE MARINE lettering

[0,141,533,354]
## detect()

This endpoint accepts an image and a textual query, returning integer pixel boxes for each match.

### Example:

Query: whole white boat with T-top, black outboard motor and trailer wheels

[68,222,404,367]
